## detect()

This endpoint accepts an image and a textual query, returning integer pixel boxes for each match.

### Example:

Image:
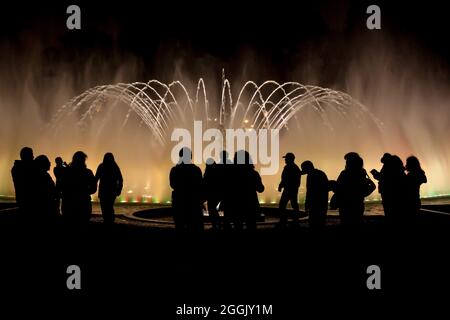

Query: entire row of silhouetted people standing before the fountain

[11,147,427,232]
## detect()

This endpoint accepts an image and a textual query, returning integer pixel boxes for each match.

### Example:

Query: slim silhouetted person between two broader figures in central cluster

[203,158,221,230]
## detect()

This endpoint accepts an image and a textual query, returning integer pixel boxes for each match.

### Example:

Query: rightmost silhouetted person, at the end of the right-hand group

[405,156,427,217]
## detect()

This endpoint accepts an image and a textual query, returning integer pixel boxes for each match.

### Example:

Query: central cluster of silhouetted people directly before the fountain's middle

[170,148,264,231]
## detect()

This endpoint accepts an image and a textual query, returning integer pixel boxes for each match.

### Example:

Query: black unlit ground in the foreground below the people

[0,204,450,319]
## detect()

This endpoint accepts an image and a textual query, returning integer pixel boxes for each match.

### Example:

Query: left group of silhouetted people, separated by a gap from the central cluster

[11,147,123,225]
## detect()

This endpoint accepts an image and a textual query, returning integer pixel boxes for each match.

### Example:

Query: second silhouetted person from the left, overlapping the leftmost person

[33,155,59,224]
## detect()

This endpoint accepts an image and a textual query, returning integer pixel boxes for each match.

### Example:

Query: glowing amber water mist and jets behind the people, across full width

[0,40,450,202]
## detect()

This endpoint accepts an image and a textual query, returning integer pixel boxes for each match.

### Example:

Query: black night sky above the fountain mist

[0,0,450,84]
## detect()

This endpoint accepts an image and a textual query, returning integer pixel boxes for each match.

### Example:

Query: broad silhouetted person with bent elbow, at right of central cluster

[224,150,264,230]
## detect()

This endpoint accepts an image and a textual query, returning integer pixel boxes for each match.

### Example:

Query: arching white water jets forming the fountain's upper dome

[52,79,381,145]
